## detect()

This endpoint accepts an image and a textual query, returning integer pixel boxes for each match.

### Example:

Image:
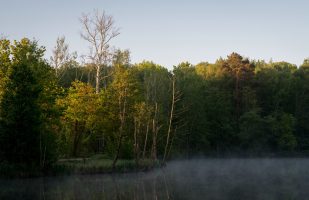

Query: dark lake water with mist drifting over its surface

[0,159,309,200]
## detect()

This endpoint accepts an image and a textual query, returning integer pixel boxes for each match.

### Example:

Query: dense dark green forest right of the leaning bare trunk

[170,53,309,155]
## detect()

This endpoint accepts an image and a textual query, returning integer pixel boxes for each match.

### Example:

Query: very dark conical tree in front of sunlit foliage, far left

[0,63,42,165]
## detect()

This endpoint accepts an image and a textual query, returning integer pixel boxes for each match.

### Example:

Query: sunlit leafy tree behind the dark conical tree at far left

[0,38,59,168]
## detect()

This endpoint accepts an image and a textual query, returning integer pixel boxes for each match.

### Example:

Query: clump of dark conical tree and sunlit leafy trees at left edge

[0,38,57,168]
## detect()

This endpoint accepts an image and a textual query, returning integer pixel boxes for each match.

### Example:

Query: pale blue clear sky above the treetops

[0,0,309,69]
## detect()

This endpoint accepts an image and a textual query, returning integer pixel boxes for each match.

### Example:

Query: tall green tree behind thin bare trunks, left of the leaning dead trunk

[133,61,171,161]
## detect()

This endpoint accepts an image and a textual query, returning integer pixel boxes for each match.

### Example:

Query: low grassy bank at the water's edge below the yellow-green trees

[0,155,159,178]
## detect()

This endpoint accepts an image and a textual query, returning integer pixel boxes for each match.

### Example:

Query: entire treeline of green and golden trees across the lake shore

[0,39,309,168]
